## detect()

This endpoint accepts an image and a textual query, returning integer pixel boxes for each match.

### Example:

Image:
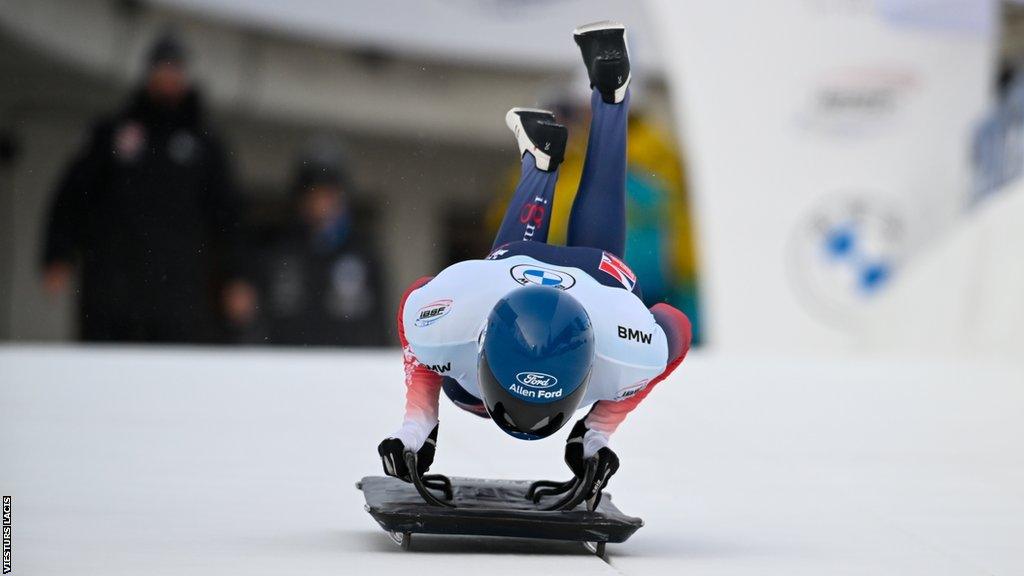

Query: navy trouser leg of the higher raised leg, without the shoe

[566,90,630,257]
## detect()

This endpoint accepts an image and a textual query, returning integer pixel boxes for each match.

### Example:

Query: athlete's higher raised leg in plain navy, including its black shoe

[567,23,630,256]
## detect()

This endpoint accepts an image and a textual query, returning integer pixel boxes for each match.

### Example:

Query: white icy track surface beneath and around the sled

[0,346,1024,576]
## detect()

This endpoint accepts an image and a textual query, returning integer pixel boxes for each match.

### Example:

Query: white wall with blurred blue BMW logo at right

[650,0,994,352]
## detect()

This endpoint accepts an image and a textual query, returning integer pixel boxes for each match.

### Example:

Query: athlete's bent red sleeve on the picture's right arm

[587,303,692,436]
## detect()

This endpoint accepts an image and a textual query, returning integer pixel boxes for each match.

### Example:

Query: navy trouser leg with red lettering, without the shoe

[490,152,558,250]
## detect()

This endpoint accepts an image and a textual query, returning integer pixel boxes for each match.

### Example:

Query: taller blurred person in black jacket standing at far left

[44,33,251,342]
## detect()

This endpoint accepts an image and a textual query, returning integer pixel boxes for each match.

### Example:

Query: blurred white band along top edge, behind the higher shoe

[155,0,660,70]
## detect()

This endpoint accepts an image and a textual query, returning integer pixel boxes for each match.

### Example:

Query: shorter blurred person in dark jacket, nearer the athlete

[243,137,390,346]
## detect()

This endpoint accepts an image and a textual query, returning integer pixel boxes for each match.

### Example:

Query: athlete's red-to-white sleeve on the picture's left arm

[394,277,441,450]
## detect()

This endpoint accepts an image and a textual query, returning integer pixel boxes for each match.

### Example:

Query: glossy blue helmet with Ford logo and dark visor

[477,286,594,440]
